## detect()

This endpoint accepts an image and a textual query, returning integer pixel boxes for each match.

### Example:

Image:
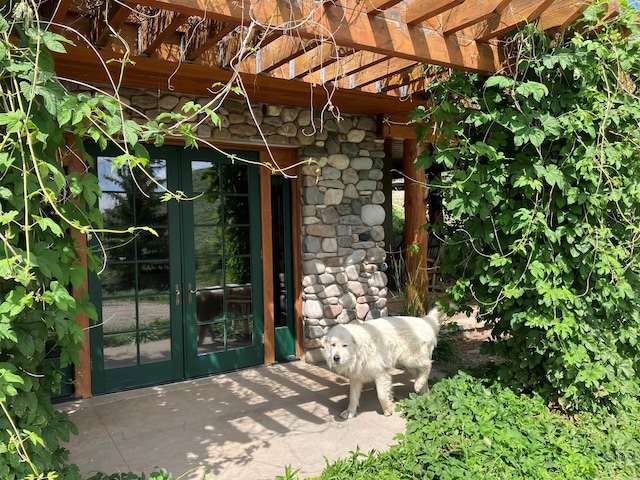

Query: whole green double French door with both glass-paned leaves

[87,142,264,393]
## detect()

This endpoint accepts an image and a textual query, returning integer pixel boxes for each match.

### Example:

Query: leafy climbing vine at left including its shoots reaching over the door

[0,2,232,480]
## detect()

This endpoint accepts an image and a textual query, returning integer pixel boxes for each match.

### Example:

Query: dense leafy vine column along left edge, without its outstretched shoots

[0,3,98,480]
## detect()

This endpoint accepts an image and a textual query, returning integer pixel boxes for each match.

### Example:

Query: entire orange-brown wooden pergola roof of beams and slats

[41,0,604,117]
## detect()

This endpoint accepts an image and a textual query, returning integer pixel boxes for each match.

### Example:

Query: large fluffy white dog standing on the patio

[324,308,441,418]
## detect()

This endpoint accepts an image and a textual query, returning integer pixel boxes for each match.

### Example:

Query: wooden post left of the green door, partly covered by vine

[65,135,91,398]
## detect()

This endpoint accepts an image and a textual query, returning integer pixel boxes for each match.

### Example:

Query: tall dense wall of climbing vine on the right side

[413,1,640,409]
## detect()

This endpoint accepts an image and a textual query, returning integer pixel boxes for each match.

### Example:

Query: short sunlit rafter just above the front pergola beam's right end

[463,0,555,42]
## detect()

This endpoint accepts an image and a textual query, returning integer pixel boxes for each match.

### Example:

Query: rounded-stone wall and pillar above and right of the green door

[80,87,387,362]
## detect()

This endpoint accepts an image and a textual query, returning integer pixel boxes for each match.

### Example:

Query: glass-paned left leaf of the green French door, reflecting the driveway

[91,151,179,391]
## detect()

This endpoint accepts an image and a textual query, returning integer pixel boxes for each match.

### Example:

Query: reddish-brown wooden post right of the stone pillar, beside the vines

[402,139,429,314]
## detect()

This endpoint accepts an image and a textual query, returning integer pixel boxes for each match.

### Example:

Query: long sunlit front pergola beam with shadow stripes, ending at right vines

[127,0,503,74]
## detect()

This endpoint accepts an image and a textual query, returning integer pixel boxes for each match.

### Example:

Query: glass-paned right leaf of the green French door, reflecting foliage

[183,151,263,376]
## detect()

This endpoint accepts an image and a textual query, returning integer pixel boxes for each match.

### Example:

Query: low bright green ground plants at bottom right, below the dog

[319,373,640,480]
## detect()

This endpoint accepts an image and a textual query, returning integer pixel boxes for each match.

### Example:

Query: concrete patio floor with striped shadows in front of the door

[58,362,412,480]
